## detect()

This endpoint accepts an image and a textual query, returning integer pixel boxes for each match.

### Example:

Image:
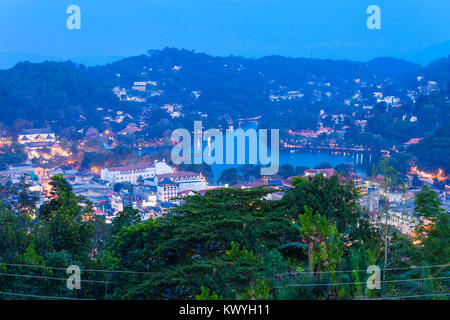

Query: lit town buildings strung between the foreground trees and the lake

[0,122,450,235]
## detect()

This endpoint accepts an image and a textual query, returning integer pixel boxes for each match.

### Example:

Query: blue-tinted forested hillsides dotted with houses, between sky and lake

[0,48,450,175]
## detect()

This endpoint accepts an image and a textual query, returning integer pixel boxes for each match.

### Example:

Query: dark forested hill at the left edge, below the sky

[0,62,117,127]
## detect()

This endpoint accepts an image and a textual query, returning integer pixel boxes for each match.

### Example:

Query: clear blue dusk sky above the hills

[0,0,450,65]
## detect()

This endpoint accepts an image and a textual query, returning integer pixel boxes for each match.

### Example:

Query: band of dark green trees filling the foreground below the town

[0,175,450,300]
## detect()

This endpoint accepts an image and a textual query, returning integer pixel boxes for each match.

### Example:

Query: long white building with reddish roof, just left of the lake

[101,160,174,184]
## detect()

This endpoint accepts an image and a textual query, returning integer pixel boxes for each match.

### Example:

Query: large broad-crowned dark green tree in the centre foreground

[108,188,295,299]
